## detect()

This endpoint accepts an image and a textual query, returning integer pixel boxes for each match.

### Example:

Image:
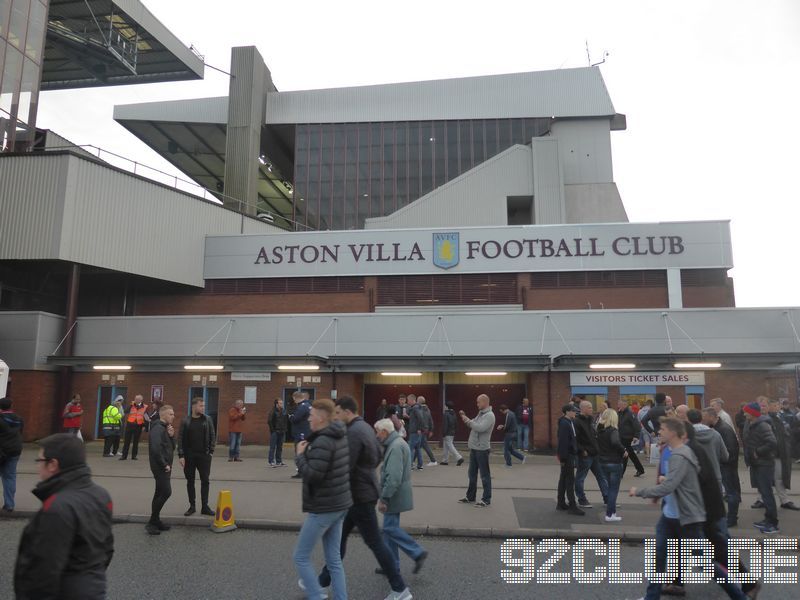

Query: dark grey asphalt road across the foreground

[0,519,800,600]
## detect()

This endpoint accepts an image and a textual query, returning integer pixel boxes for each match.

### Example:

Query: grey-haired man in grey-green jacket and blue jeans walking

[375,419,428,580]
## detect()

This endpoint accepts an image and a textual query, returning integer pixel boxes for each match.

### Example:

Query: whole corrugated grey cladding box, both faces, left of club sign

[0,154,281,287]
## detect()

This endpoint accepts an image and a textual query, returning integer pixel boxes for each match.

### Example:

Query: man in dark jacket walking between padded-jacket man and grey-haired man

[319,396,406,594]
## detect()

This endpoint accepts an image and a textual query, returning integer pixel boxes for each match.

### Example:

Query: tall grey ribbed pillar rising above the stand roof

[223,46,275,215]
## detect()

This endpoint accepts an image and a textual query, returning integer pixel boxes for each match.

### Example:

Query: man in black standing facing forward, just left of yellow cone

[178,398,217,517]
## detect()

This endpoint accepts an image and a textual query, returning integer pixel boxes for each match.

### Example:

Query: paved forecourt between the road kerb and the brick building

[6,442,800,542]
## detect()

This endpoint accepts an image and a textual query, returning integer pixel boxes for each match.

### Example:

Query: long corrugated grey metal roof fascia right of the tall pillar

[266,67,615,124]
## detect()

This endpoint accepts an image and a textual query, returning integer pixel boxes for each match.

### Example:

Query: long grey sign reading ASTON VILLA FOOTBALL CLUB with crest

[204,221,733,279]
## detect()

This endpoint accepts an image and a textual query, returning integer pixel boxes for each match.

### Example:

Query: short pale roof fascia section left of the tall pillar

[114,96,228,125]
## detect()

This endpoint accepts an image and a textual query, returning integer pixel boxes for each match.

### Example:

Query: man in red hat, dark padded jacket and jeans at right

[744,402,778,533]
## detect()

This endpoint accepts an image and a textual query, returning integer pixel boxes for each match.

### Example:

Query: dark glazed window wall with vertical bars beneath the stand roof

[293,119,550,229]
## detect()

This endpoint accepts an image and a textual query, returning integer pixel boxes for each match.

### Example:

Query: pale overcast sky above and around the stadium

[37,0,800,306]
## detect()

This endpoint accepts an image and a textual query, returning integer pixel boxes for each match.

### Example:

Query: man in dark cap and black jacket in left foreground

[14,433,114,600]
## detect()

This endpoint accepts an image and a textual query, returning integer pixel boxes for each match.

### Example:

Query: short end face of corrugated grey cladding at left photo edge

[0,156,68,259]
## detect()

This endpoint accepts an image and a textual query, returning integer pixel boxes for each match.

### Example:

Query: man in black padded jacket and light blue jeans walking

[294,400,353,600]
